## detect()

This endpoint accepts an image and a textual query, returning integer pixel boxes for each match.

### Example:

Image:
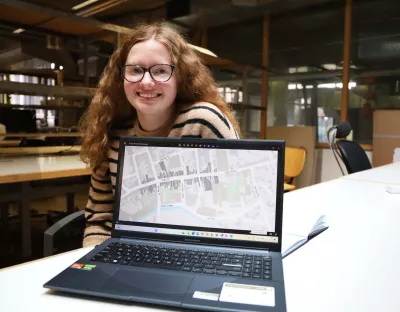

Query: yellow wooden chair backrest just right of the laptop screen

[285,147,307,185]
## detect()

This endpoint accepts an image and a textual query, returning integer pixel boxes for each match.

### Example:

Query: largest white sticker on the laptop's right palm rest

[219,283,275,307]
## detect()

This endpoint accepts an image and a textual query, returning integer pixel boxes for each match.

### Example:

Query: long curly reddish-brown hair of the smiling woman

[79,22,240,168]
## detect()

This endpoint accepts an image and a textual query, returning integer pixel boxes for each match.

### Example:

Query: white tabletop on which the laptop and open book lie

[0,171,400,312]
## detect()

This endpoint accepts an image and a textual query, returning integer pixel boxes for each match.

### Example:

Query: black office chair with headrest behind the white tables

[328,121,372,175]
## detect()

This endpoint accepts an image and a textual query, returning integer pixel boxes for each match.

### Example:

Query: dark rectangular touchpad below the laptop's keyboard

[101,270,193,302]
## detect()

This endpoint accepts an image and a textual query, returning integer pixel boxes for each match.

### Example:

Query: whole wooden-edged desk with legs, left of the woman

[0,155,91,257]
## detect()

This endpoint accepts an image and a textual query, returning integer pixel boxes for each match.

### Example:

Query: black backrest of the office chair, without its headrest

[336,140,372,174]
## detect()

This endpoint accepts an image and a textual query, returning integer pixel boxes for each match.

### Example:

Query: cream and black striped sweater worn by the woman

[83,102,239,247]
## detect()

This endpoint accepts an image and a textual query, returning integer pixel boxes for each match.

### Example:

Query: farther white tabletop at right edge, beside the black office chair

[342,162,400,185]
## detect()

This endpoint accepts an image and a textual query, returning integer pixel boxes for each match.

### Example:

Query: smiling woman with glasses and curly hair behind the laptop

[80,23,239,246]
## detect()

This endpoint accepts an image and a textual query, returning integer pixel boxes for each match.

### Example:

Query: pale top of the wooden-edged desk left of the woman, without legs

[0,155,90,184]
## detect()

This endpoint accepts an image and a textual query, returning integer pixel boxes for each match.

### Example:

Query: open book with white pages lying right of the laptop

[282,205,328,258]
